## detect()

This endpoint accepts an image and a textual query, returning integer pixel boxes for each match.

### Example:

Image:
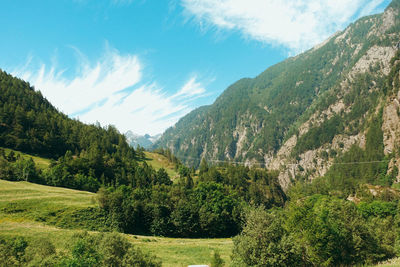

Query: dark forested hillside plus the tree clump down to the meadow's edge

[0,68,286,237]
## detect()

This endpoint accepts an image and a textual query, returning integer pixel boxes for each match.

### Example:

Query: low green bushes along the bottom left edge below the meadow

[0,233,161,267]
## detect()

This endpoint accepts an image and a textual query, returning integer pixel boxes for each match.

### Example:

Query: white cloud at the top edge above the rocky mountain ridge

[181,0,384,53]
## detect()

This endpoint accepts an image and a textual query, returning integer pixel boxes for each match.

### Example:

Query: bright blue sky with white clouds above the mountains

[0,0,390,135]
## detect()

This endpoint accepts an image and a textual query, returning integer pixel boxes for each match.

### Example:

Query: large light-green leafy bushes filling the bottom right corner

[233,195,395,266]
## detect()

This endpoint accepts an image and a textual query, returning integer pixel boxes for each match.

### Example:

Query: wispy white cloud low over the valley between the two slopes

[12,46,206,134]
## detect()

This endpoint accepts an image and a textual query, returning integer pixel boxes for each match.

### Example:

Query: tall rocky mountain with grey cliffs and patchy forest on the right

[156,0,400,187]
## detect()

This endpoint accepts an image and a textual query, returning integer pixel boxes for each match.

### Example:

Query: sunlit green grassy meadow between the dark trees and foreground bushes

[0,180,233,266]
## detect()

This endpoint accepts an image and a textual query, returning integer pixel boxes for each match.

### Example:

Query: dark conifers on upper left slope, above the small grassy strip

[0,71,134,159]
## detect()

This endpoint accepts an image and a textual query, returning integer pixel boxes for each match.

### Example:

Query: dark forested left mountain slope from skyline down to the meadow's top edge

[0,70,155,192]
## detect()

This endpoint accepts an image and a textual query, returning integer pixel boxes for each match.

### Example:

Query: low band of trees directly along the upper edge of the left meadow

[0,144,172,195]
